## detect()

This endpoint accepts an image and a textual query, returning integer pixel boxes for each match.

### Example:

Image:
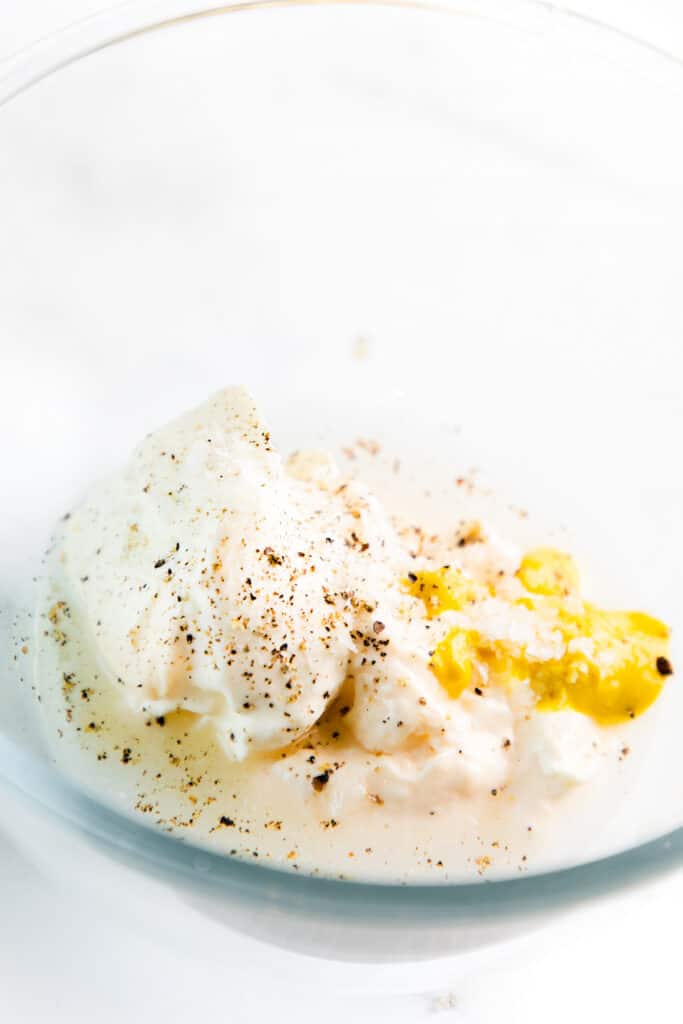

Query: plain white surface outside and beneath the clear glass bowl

[0,6,683,1024]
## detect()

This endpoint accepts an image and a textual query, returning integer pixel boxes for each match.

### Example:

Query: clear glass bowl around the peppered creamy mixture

[0,0,683,958]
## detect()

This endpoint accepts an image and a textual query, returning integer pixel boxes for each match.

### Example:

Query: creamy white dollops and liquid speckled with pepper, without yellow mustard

[36,389,643,881]
